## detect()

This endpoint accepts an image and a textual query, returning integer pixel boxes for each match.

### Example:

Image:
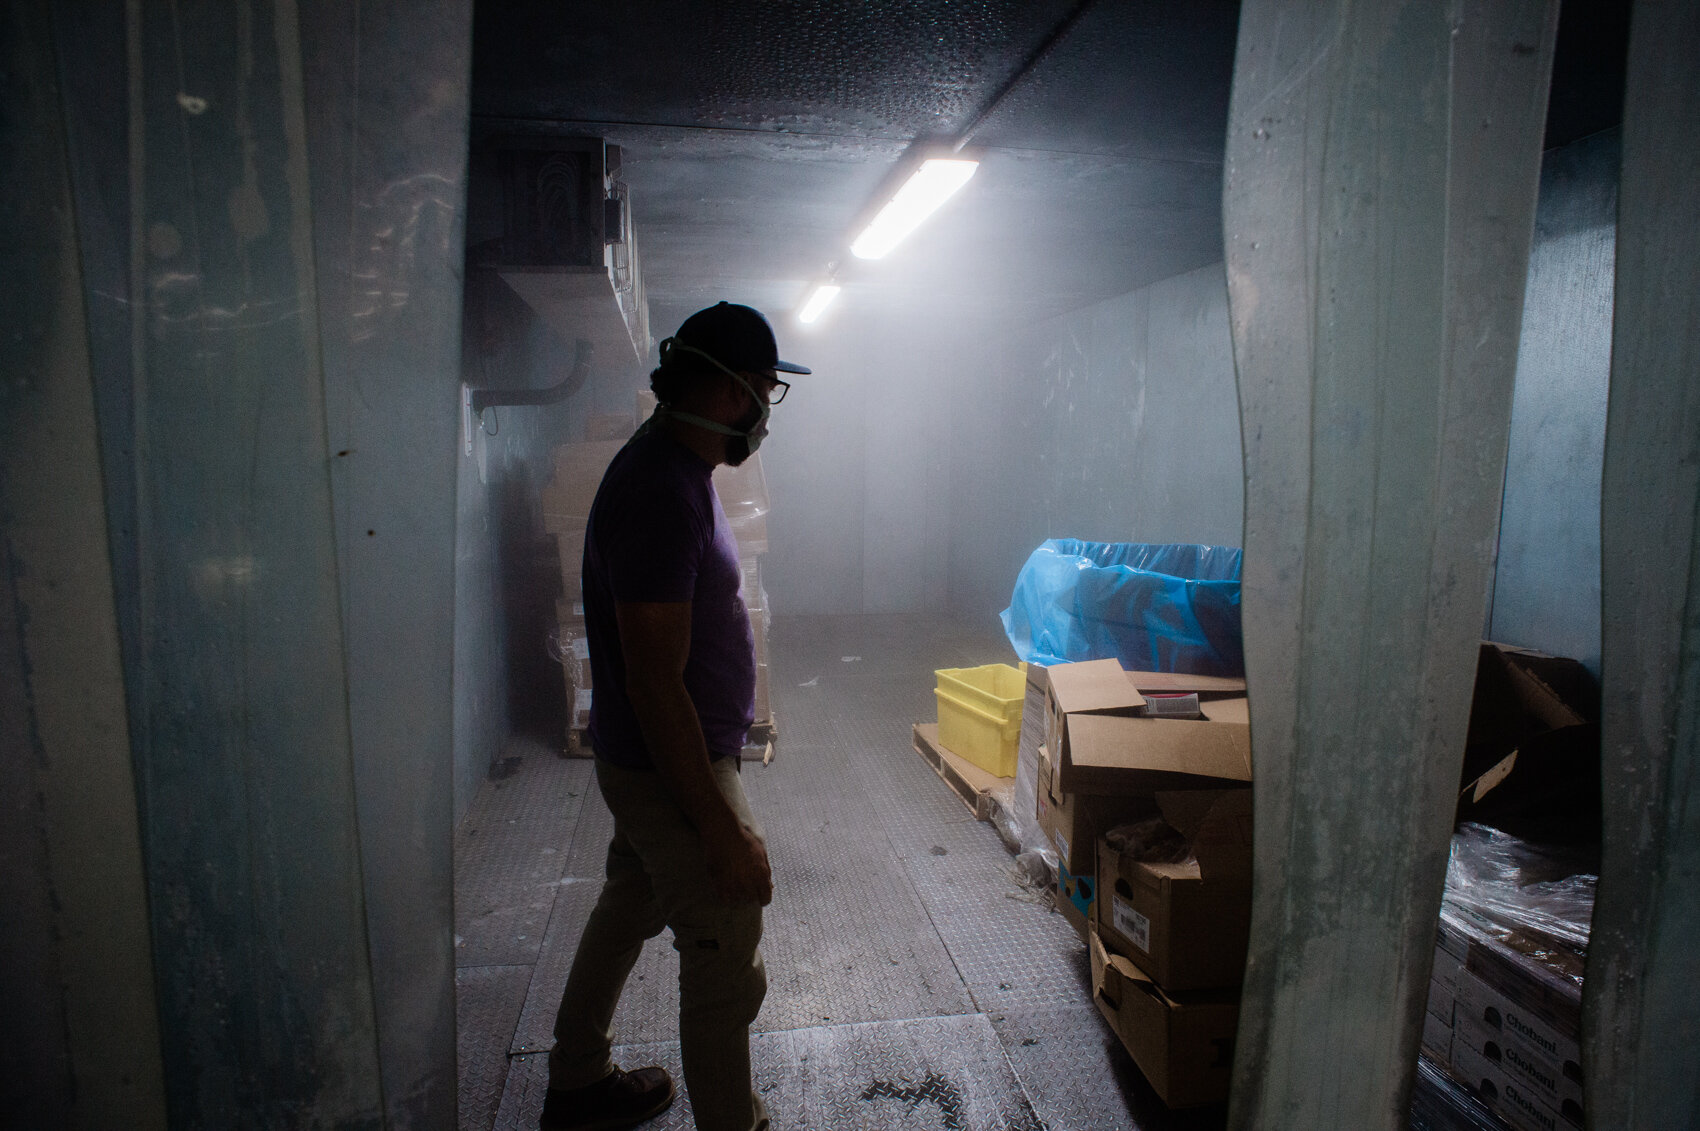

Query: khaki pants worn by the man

[549,759,767,1131]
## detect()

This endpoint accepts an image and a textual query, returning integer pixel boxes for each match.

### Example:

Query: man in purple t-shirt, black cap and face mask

[541,303,809,1131]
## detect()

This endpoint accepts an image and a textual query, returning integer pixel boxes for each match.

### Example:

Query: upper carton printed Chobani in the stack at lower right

[1454,969,1584,1126]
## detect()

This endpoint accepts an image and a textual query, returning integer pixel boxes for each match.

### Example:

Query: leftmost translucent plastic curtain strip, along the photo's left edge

[0,0,167,1129]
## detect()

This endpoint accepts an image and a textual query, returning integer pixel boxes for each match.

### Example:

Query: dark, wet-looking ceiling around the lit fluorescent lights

[473,0,1238,335]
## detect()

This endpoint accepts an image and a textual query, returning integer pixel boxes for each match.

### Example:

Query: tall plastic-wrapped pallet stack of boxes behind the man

[541,393,774,750]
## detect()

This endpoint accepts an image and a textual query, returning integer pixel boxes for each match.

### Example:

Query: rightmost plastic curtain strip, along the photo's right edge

[1583,2,1700,1128]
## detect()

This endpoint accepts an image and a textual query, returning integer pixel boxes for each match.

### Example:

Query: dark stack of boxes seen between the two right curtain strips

[1423,641,1600,1131]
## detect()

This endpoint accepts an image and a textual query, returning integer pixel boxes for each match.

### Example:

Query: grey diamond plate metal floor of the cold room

[456,616,1222,1131]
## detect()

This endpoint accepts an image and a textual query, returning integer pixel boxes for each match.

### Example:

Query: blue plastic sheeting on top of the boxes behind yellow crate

[1001,537,1246,675]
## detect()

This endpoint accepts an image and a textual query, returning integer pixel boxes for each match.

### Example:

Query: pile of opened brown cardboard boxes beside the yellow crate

[1030,660,1251,1107]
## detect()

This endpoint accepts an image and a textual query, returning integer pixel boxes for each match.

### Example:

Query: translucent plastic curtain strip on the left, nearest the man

[301,0,471,1128]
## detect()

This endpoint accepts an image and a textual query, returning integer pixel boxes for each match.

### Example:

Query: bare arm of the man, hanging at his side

[614,600,774,905]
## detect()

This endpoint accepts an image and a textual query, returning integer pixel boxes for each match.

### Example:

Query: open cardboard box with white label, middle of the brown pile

[1098,789,1251,993]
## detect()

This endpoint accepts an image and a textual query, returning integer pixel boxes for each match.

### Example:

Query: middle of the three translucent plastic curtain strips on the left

[128,0,383,1128]
